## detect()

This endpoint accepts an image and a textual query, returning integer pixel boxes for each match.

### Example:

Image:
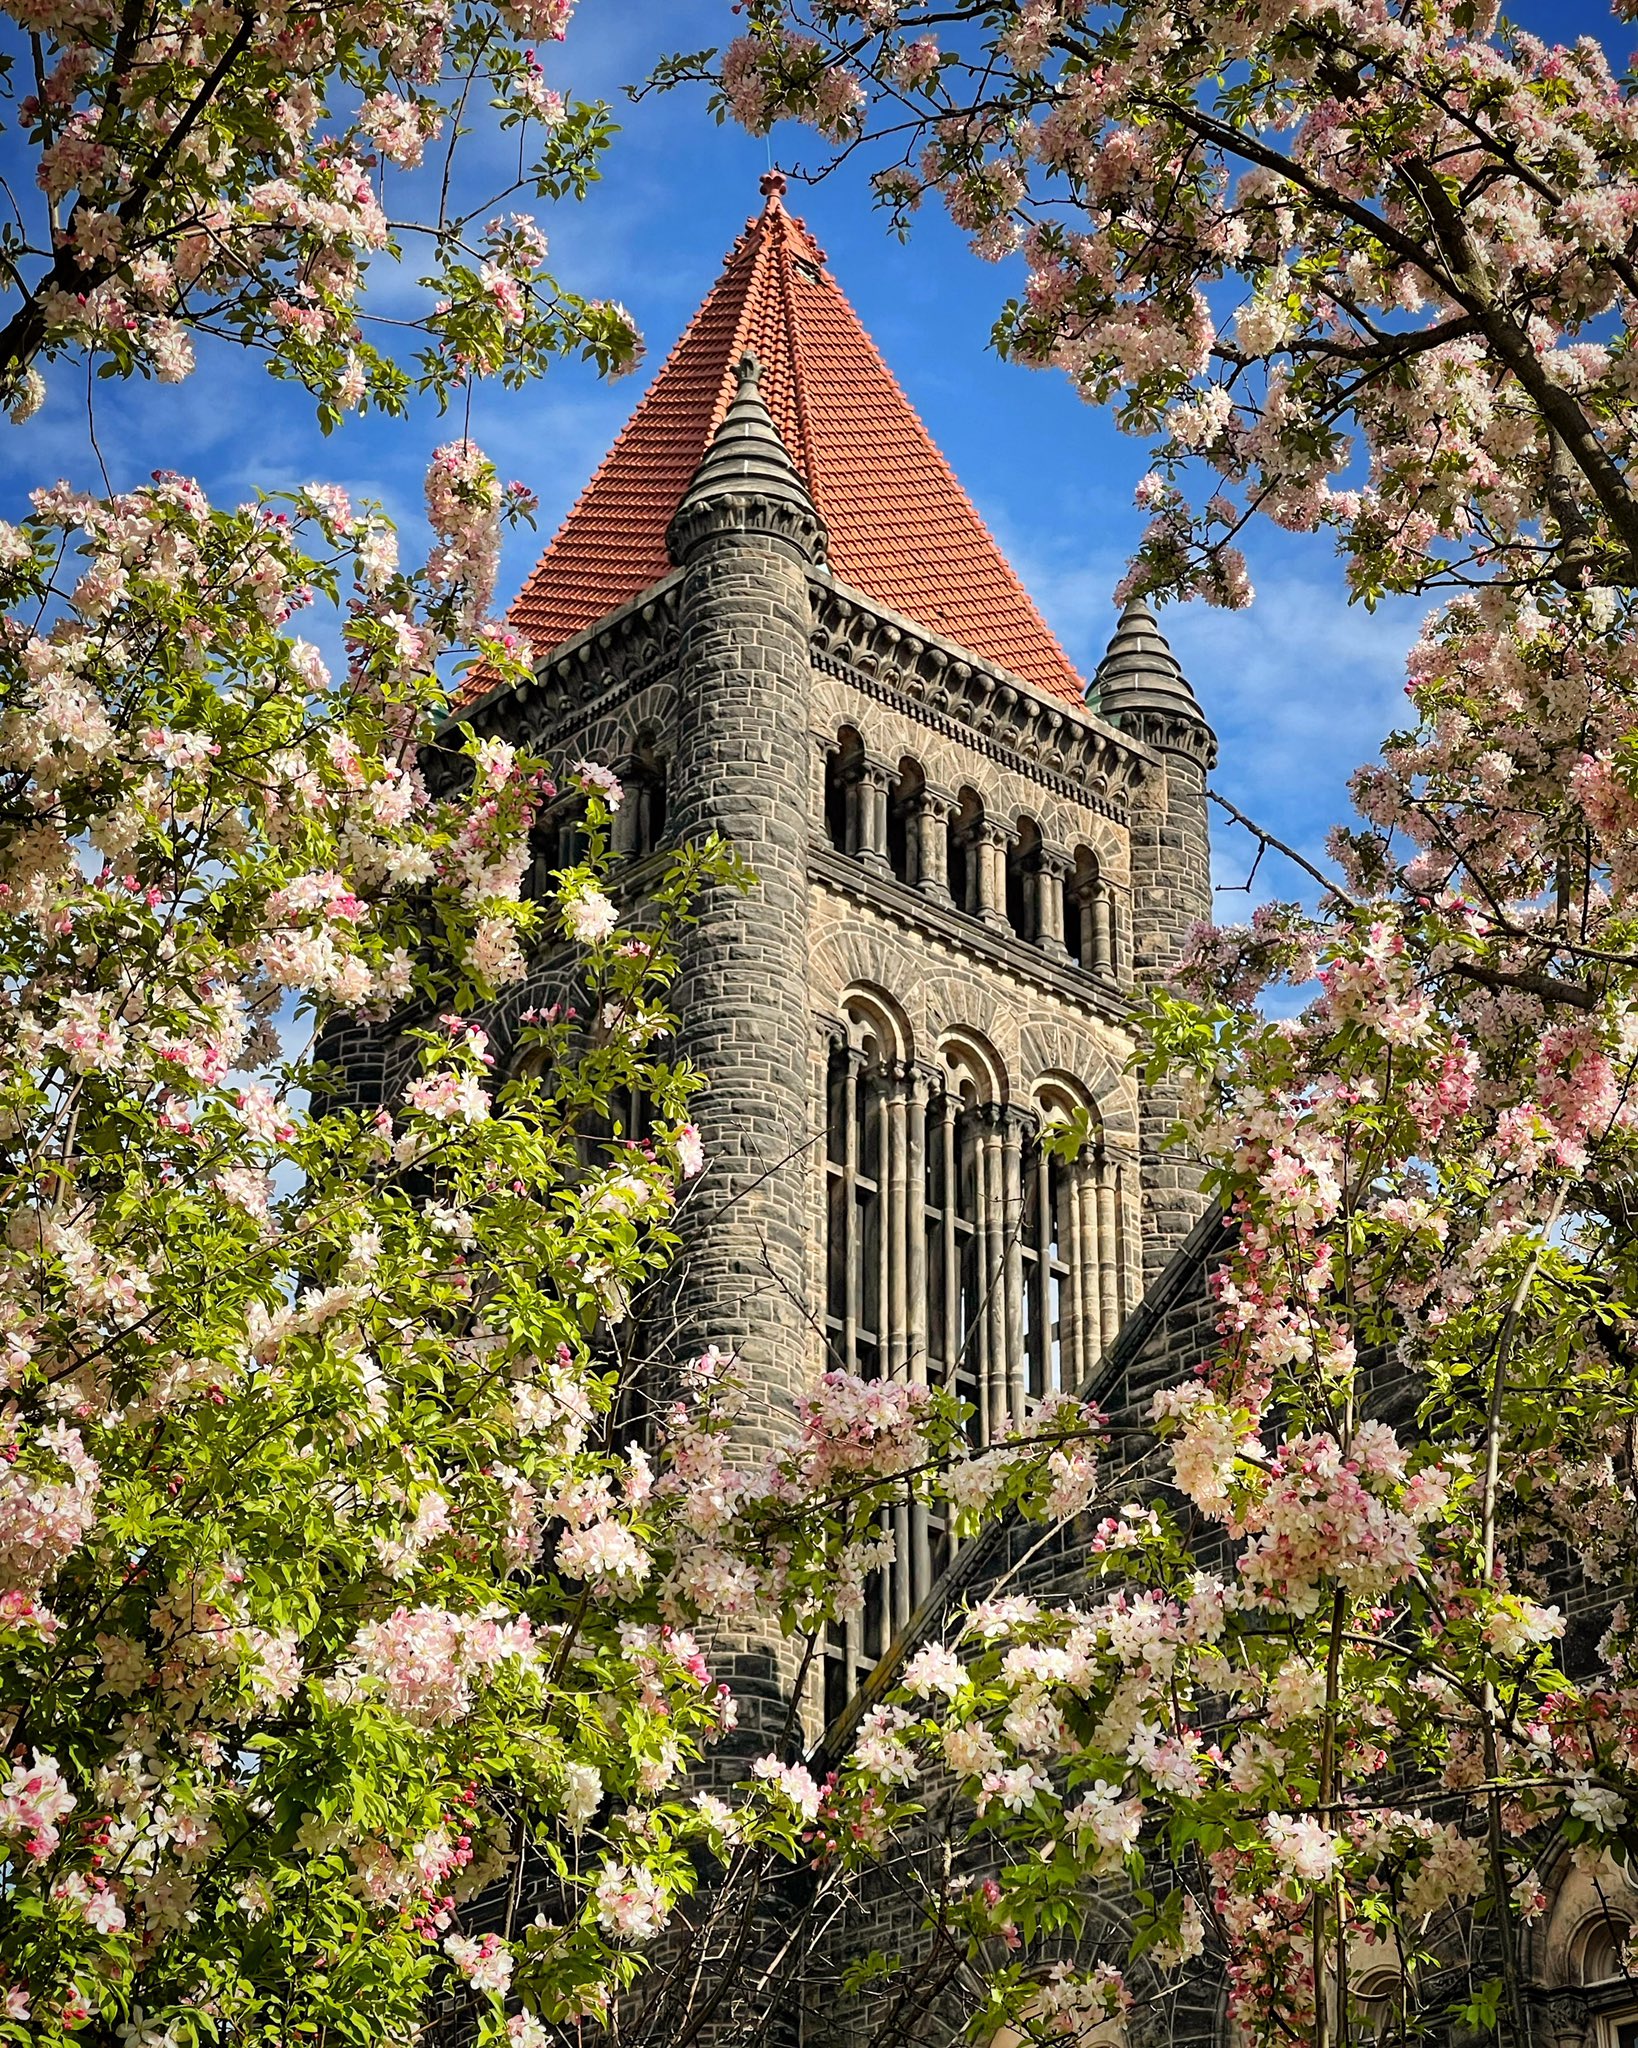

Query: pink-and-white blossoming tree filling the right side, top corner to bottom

[642,0,1638,2042]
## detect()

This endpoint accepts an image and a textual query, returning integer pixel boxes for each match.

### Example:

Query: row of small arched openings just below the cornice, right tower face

[825,725,1126,979]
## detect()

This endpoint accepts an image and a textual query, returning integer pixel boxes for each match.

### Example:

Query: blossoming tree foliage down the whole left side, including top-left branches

[0,0,1031,2048]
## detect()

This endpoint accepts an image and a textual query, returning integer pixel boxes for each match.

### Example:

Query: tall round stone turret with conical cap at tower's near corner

[667,354,827,1434]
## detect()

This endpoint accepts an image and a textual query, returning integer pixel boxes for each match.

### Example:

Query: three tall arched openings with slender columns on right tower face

[823,985,1132,1710]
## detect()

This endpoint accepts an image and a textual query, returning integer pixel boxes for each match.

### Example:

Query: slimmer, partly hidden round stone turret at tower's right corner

[1093,598,1216,1282]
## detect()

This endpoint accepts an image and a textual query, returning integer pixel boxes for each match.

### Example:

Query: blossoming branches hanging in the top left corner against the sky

[0,0,637,430]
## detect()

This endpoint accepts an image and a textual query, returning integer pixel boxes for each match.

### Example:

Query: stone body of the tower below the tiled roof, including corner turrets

[454,356,1214,1733]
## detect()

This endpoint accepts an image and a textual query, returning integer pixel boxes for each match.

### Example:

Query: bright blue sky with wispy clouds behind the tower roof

[0,0,1628,918]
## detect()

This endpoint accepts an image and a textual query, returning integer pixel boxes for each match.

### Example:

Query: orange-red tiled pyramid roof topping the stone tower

[499,172,1085,720]
